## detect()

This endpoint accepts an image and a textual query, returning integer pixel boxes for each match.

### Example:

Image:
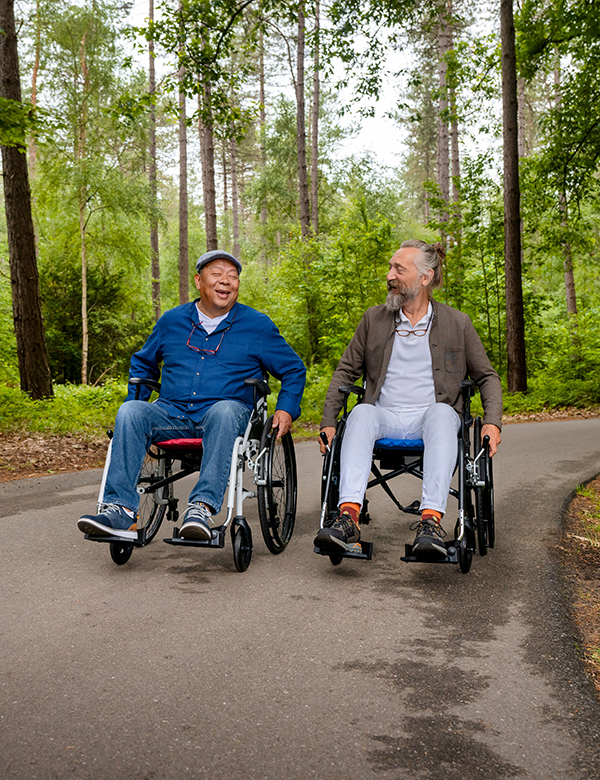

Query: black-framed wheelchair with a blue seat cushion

[314,380,495,574]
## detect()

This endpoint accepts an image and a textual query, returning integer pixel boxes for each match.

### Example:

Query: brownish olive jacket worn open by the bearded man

[321,300,502,428]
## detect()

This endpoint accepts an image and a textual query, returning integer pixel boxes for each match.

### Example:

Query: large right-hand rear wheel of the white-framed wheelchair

[257,417,298,555]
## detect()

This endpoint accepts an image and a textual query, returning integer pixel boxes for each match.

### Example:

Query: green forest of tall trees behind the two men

[0,0,600,425]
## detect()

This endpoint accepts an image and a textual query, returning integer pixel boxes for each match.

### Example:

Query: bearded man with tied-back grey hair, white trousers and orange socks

[315,240,502,559]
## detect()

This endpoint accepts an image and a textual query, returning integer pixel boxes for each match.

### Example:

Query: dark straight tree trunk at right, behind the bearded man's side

[500,0,527,393]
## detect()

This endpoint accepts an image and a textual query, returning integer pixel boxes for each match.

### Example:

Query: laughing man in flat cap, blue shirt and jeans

[77,250,306,540]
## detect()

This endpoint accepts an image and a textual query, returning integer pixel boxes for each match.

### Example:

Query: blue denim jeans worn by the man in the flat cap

[104,401,250,514]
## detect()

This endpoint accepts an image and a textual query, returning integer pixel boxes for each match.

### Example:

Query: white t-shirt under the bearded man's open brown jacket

[375,301,435,412]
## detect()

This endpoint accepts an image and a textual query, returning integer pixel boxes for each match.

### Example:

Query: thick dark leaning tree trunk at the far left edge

[0,0,53,399]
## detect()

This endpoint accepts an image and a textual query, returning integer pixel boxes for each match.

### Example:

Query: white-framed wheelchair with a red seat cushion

[85,377,298,572]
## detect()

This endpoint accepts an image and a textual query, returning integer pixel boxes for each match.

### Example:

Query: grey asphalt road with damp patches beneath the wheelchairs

[0,420,600,780]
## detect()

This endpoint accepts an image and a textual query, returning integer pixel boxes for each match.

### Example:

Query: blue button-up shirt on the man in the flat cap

[127,301,306,422]
